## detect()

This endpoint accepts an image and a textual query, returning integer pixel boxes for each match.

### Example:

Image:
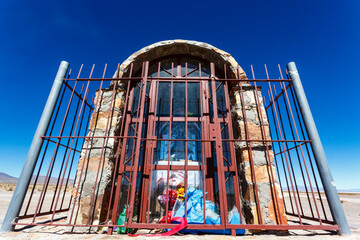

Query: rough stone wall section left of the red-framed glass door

[69,85,125,228]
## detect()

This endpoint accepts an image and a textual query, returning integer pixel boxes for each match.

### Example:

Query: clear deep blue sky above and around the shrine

[0,0,360,188]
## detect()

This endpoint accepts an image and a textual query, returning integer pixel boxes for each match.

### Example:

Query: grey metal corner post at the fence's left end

[0,61,69,232]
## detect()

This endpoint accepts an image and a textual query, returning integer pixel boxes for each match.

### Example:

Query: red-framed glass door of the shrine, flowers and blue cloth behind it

[113,56,241,232]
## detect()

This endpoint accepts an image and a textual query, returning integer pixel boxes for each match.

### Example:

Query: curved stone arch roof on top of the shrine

[114,39,246,79]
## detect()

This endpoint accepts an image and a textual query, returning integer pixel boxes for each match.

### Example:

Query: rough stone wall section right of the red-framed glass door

[230,83,286,224]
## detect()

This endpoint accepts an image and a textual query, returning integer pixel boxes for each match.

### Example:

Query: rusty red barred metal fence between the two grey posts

[4,62,346,234]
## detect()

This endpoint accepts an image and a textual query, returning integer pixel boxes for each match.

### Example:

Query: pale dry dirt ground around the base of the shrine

[0,189,360,240]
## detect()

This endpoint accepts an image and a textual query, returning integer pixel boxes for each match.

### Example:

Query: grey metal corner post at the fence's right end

[286,62,351,235]
